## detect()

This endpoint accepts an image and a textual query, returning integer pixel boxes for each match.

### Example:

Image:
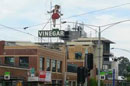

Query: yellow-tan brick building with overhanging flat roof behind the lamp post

[64,37,113,78]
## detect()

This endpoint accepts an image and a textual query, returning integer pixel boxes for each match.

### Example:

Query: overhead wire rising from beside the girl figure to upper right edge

[64,3,130,19]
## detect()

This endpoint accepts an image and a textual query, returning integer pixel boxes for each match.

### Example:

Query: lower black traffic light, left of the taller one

[77,67,88,83]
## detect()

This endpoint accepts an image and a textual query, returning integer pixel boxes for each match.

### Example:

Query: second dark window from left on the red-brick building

[19,57,29,68]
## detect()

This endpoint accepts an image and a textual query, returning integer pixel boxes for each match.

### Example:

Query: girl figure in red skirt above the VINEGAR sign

[48,5,63,27]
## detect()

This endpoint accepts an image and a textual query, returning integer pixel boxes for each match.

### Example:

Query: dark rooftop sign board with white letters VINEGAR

[38,29,65,37]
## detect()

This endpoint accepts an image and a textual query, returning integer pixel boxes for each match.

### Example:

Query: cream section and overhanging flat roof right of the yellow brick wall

[72,37,114,69]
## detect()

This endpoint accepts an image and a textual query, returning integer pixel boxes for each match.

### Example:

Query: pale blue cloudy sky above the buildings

[0,0,130,59]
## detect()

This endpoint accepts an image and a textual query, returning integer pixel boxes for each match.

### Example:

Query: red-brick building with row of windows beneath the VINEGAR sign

[0,41,76,86]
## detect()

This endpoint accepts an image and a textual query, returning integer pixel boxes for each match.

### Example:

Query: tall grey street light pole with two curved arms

[62,19,130,86]
